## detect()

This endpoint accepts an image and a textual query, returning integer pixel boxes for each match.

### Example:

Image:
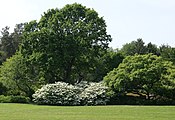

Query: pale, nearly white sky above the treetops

[0,0,175,49]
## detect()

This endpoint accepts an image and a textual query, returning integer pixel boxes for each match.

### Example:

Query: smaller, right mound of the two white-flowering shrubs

[79,82,109,105]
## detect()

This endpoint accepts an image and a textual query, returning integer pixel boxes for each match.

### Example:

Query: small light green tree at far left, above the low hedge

[0,53,41,98]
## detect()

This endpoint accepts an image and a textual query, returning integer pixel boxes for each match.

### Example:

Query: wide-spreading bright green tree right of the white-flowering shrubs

[104,54,175,99]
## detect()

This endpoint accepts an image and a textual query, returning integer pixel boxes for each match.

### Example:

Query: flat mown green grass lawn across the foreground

[0,103,175,120]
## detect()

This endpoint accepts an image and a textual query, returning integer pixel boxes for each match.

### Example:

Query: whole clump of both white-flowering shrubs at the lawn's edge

[33,82,108,105]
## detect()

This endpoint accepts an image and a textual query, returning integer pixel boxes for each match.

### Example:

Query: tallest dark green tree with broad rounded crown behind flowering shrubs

[20,3,111,83]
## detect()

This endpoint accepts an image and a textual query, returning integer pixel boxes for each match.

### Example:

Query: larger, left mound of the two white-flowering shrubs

[33,82,80,105]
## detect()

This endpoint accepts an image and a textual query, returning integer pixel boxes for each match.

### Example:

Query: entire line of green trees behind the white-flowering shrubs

[0,3,175,103]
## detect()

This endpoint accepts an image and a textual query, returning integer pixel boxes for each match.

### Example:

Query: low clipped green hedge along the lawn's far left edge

[0,95,30,103]
